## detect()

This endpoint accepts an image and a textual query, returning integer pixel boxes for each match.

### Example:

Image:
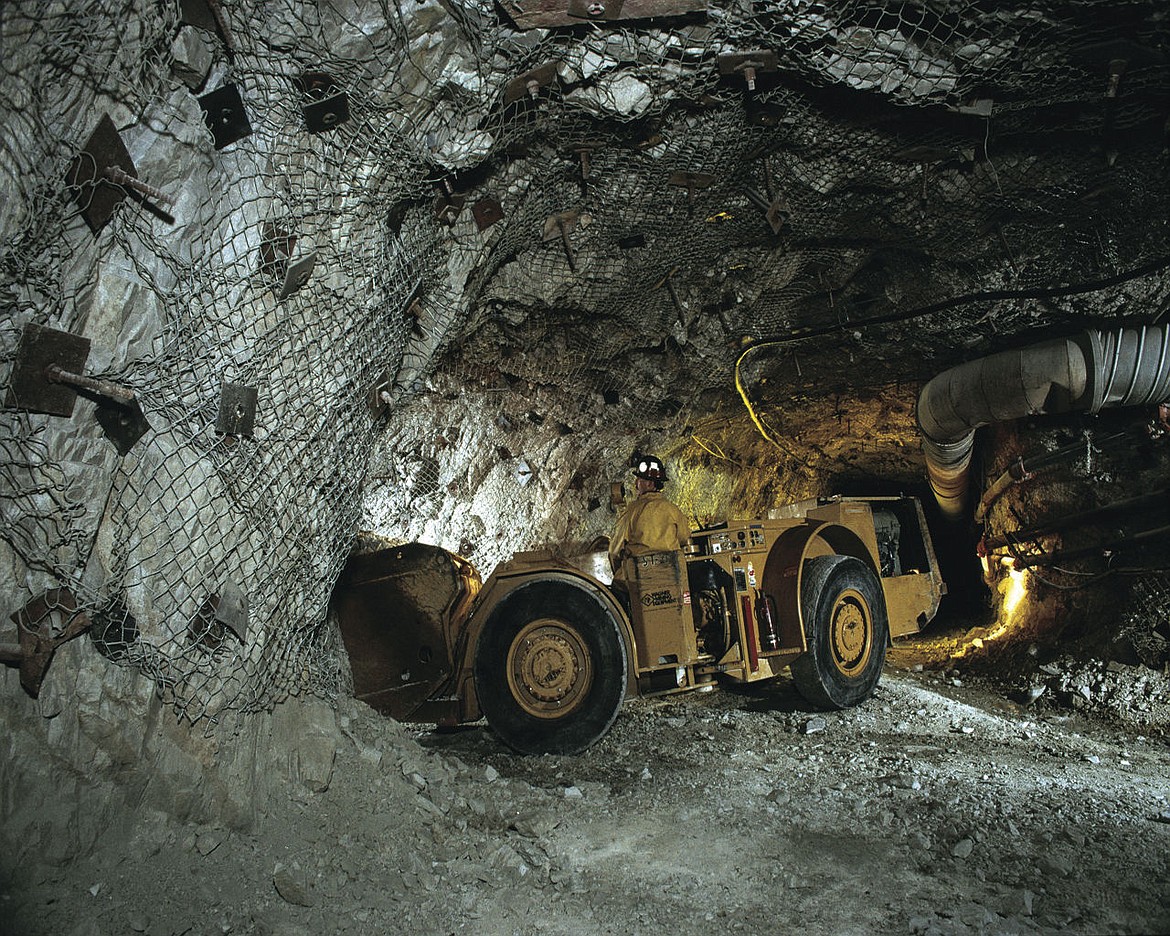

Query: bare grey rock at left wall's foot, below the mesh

[0,641,342,865]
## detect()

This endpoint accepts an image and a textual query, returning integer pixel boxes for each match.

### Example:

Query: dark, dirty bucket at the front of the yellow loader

[332,543,479,721]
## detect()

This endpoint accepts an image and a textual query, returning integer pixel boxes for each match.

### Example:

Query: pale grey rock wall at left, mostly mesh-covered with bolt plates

[0,2,444,853]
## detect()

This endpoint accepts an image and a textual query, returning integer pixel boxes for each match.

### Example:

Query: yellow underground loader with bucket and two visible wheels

[332,497,945,753]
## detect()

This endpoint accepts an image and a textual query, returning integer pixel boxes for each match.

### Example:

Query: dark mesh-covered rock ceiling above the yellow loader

[404,4,1170,428]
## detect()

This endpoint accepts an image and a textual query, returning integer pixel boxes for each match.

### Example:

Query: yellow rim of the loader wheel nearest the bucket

[508,618,593,718]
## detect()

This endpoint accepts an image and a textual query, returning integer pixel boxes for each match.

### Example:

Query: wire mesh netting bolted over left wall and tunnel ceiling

[0,0,1170,721]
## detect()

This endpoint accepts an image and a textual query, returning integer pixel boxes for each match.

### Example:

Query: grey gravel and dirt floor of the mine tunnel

[0,648,1170,936]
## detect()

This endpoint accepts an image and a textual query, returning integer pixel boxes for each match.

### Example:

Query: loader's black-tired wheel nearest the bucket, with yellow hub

[475,580,626,755]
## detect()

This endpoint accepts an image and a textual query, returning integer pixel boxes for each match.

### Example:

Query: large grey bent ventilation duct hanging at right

[917,325,1170,519]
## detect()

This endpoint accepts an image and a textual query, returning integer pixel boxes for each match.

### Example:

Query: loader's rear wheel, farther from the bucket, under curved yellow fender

[791,556,889,709]
